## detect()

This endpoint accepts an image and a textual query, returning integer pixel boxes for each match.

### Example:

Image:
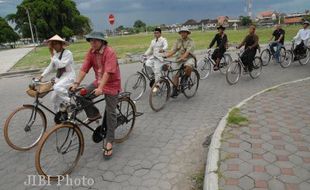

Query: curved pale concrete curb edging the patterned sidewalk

[203,77,310,190]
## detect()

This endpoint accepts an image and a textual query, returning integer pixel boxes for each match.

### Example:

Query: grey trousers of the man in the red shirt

[79,84,118,142]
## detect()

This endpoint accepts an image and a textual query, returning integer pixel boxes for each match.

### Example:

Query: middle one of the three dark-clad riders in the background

[237,25,259,72]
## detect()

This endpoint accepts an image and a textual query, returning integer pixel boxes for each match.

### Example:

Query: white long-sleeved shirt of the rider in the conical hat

[42,49,75,80]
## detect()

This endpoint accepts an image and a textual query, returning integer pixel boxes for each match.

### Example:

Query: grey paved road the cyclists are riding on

[0,57,310,190]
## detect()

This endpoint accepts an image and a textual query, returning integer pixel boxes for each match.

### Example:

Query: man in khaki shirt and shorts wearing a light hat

[165,27,196,98]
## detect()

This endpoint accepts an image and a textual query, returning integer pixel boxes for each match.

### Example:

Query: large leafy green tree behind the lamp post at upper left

[7,0,91,39]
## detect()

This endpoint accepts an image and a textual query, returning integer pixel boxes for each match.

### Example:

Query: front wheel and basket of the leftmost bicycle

[3,78,56,151]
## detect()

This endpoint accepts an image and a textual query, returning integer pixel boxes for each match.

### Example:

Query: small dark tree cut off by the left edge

[0,17,19,43]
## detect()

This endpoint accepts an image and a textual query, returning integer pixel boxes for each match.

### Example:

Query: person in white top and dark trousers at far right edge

[294,21,310,61]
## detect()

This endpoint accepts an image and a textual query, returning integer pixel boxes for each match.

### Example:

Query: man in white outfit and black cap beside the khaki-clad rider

[144,28,168,85]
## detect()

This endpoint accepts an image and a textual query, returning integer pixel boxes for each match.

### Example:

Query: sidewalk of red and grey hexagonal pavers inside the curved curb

[217,80,310,190]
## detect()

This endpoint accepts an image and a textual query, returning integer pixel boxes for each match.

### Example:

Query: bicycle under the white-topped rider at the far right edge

[281,40,310,68]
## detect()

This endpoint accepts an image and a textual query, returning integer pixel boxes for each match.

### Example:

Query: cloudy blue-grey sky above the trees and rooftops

[0,0,310,30]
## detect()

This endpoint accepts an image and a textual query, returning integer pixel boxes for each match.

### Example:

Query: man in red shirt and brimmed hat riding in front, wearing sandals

[72,32,121,158]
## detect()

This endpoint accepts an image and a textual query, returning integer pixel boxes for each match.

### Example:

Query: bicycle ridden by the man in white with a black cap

[124,56,155,101]
